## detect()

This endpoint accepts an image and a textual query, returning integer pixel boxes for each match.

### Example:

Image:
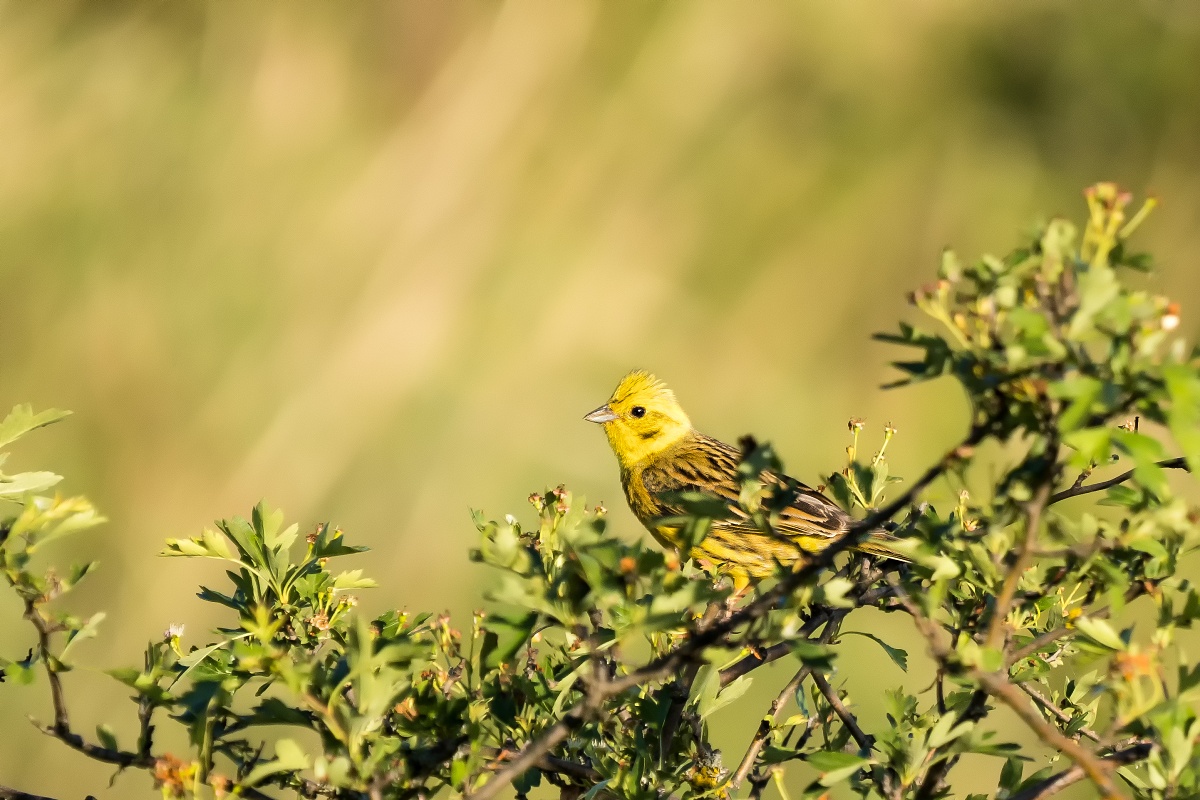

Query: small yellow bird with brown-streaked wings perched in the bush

[583,371,907,593]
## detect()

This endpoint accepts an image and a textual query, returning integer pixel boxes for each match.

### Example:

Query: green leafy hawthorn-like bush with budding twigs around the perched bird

[0,185,1200,800]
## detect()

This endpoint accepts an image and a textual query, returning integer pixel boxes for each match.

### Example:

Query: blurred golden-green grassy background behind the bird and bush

[0,0,1200,798]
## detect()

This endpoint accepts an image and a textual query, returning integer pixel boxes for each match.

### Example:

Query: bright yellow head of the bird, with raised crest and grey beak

[583,369,691,467]
